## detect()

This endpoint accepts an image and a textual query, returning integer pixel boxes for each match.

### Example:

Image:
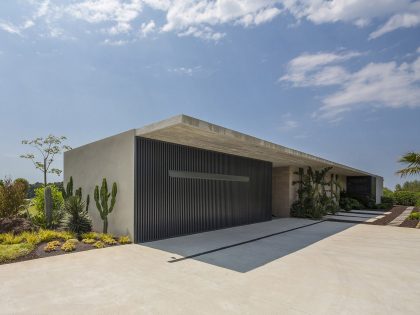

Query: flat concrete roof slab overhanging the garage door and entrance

[136,115,380,177]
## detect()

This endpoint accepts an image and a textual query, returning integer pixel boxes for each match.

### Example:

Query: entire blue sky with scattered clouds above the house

[0,0,420,187]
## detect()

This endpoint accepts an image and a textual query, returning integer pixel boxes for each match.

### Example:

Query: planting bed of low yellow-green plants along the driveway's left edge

[0,230,130,265]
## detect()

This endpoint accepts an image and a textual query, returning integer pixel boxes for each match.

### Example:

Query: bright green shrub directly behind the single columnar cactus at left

[32,185,64,228]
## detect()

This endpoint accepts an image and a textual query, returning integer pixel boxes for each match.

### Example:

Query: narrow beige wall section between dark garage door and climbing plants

[272,166,292,217]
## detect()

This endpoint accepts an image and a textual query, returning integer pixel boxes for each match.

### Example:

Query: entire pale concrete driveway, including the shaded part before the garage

[0,219,420,314]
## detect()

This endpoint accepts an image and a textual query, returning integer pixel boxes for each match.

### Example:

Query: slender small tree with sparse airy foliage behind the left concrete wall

[20,135,71,187]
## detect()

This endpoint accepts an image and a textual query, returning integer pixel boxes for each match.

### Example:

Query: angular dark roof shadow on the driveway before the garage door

[141,218,355,273]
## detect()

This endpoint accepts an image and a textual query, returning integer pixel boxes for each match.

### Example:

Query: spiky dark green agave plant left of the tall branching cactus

[62,196,92,235]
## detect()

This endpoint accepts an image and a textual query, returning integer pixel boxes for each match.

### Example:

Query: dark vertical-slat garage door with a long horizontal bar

[135,137,272,242]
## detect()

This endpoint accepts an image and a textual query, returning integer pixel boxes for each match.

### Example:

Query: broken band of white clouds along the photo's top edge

[0,0,420,41]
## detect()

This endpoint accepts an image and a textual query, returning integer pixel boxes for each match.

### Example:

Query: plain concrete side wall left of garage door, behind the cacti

[64,130,135,239]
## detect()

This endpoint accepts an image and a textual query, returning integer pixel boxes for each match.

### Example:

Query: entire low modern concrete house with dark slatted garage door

[64,115,383,242]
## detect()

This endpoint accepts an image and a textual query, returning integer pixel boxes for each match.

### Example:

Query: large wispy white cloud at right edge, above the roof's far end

[280,53,420,120]
